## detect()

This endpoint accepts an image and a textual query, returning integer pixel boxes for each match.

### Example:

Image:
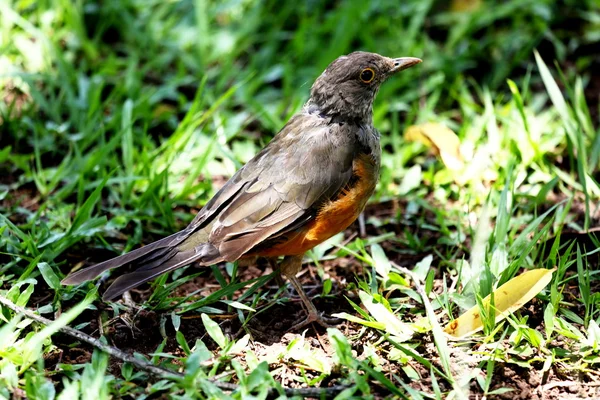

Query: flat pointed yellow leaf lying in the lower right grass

[444,268,556,338]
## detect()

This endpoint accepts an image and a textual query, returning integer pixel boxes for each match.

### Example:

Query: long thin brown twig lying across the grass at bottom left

[0,296,349,398]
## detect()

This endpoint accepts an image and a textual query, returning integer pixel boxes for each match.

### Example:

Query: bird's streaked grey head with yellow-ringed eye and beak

[305,51,421,123]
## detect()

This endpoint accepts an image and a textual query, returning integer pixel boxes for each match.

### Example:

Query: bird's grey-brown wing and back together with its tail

[63,114,356,300]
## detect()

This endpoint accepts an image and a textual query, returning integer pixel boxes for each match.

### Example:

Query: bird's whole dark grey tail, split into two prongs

[61,234,221,301]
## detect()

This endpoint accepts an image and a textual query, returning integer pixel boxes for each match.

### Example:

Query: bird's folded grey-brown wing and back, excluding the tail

[179,114,356,261]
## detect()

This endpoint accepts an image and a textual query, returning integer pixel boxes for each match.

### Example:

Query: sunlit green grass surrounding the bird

[0,0,600,399]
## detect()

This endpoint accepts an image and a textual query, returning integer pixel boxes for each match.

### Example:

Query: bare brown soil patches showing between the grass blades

[18,198,600,400]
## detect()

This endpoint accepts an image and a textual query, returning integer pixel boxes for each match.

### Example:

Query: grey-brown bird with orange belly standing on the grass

[62,51,422,330]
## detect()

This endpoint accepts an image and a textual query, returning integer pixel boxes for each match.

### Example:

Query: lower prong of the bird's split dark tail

[102,243,222,301]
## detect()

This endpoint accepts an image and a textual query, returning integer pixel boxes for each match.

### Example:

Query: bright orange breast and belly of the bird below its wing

[260,155,377,257]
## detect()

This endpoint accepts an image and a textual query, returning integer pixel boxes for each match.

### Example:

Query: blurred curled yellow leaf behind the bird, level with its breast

[404,122,464,171]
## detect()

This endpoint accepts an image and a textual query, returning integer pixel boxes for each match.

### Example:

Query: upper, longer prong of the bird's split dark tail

[61,234,179,285]
